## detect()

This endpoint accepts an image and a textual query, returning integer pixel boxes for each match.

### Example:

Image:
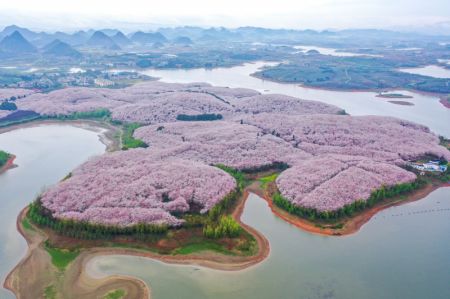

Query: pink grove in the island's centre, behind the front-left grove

[134,121,311,169]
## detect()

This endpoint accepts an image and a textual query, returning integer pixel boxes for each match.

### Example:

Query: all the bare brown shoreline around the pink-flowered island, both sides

[0,120,450,298]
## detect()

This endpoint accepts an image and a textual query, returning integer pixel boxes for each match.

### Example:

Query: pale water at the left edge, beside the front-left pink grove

[0,125,105,299]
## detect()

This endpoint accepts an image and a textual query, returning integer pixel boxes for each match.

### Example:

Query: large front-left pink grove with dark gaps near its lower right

[41,149,236,226]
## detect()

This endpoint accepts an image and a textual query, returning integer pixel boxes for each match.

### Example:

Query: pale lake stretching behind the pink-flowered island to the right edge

[142,62,450,137]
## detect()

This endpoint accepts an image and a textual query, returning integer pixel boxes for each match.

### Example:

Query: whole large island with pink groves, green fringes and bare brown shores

[0,81,450,298]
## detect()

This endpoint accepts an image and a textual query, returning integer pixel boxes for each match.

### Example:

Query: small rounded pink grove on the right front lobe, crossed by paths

[276,155,416,211]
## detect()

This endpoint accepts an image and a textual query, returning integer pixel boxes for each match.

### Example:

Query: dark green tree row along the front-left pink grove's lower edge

[27,199,168,240]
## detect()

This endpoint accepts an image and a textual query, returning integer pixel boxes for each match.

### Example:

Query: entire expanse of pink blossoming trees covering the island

[16,81,450,226]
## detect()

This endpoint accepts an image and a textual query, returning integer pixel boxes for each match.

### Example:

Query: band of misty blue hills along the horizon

[0,25,450,58]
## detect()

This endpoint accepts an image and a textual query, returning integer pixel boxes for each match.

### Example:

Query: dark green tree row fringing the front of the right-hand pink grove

[272,178,426,221]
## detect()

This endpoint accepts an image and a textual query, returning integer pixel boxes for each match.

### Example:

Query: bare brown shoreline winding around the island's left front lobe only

[4,191,270,298]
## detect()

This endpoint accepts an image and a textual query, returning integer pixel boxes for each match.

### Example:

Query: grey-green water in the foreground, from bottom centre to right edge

[88,188,450,299]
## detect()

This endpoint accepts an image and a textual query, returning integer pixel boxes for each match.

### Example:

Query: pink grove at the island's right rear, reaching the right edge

[244,113,450,163]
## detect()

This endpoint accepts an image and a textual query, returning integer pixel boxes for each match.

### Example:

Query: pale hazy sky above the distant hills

[0,0,450,31]
